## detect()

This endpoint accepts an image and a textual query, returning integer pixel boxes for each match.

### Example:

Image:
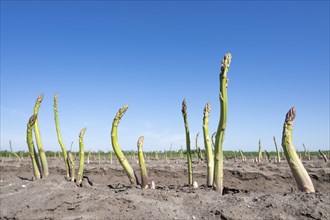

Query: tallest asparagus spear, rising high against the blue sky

[213,53,231,195]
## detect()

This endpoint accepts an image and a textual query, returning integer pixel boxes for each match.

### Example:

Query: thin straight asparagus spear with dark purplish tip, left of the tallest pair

[181,99,193,185]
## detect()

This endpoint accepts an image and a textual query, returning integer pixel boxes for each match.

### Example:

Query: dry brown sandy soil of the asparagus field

[0,157,330,219]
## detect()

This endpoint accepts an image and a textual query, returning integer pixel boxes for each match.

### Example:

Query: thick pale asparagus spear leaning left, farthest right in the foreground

[282,107,315,192]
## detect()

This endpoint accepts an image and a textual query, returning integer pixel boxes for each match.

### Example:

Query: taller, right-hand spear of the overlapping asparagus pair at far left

[33,94,49,178]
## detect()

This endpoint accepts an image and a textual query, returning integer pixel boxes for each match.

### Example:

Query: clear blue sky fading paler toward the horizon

[1,1,329,151]
